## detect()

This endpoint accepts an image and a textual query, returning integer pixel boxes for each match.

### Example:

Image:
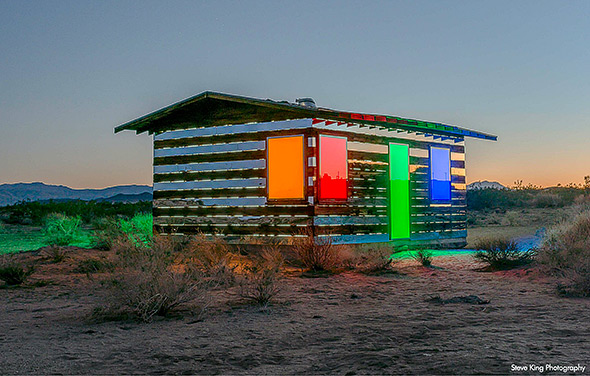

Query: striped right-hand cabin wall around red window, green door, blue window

[313,121,467,247]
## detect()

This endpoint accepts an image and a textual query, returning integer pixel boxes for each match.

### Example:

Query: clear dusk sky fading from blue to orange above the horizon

[0,0,590,188]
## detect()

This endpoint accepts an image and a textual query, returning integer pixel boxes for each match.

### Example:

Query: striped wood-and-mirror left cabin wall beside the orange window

[154,119,313,240]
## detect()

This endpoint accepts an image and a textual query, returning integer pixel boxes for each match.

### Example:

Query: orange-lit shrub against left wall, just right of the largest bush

[179,234,235,285]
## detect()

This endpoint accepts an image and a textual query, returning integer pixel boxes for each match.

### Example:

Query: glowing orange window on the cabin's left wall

[266,136,305,200]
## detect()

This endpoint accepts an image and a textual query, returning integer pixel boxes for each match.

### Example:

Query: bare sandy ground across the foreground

[0,251,590,375]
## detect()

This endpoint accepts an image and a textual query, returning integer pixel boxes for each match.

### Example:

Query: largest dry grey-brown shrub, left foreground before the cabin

[101,236,211,322]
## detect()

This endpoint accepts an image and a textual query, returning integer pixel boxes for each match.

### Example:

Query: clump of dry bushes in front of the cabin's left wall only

[93,235,283,322]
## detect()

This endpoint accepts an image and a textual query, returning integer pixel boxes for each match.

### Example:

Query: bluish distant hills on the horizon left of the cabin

[0,183,152,206]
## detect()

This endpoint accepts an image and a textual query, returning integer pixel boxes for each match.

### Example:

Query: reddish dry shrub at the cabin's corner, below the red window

[293,229,341,272]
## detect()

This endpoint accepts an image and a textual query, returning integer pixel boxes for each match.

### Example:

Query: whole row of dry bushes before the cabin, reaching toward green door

[89,226,408,321]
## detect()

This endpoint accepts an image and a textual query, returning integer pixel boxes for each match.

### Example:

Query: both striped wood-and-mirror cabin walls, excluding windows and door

[154,119,466,246]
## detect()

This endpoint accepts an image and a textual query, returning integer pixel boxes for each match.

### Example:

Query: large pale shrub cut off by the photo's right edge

[538,210,590,296]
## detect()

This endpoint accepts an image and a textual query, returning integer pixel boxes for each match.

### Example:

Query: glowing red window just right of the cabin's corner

[320,136,348,200]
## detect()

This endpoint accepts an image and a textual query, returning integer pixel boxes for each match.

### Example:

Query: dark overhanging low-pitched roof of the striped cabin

[115,91,497,141]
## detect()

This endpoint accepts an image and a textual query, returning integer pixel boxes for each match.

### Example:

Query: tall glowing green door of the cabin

[389,144,410,239]
